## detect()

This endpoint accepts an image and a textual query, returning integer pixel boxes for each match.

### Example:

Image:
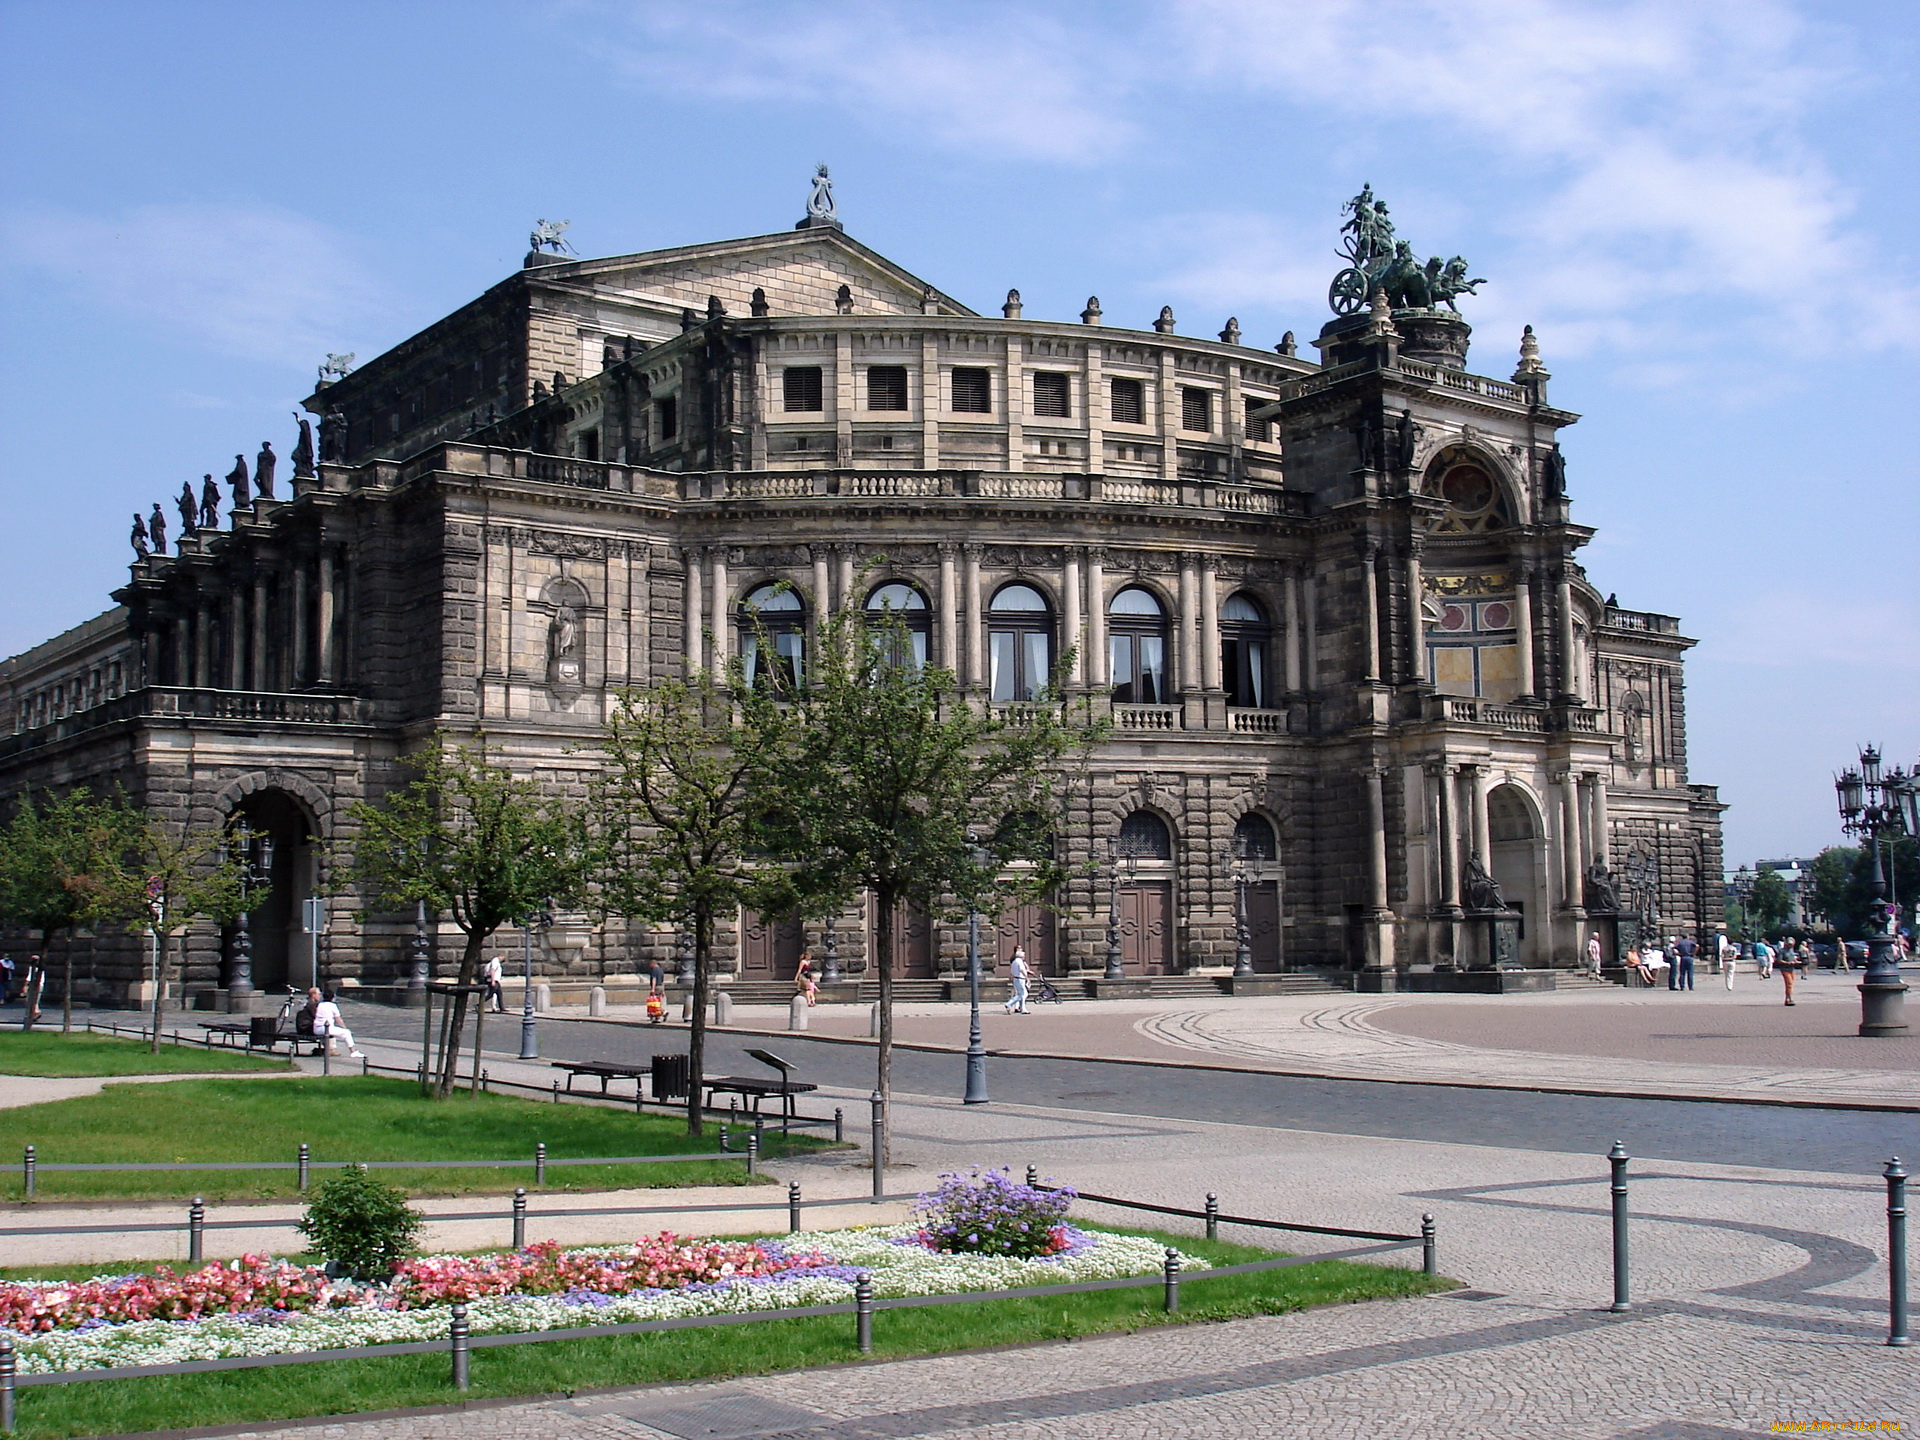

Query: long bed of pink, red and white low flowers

[0,1223,1206,1373]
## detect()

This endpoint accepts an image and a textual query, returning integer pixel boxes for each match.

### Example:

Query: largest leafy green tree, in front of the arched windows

[766,609,1100,1136]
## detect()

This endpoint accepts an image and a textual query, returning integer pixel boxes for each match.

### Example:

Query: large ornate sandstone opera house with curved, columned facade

[0,228,1720,1000]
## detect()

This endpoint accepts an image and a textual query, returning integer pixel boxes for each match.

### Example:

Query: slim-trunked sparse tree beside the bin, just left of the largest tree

[597,666,793,1135]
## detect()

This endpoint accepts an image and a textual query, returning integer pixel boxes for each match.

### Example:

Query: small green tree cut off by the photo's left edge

[0,785,142,1033]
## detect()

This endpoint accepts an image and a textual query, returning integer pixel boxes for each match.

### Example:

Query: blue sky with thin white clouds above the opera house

[0,0,1920,860]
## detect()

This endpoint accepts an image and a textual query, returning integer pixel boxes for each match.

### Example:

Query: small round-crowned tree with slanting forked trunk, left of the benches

[342,735,599,1094]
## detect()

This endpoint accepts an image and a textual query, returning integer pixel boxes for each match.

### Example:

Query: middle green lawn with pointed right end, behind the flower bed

[0,1075,824,1200]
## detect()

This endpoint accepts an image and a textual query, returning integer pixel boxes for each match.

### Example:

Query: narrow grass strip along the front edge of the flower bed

[0,1231,1459,1436]
